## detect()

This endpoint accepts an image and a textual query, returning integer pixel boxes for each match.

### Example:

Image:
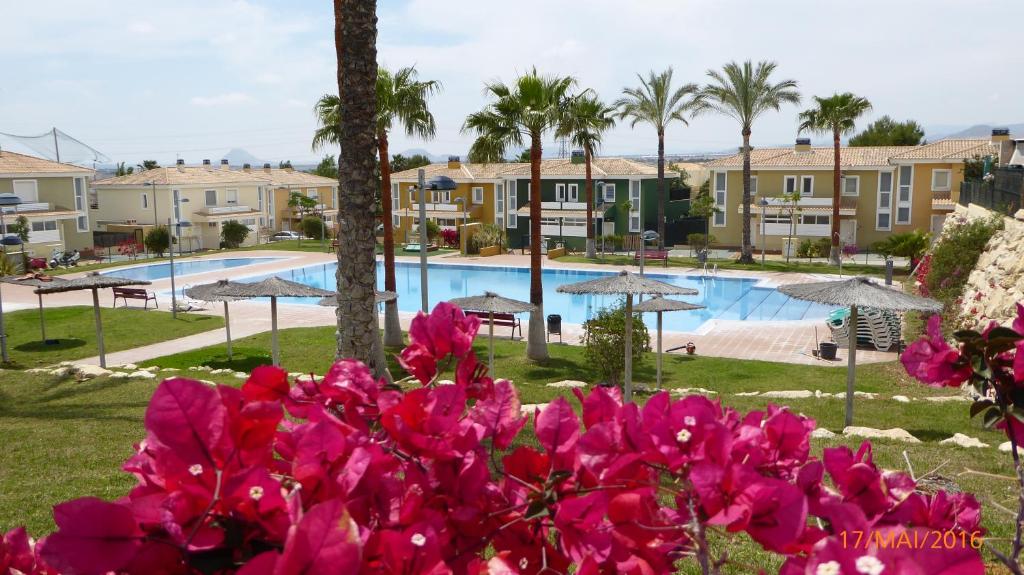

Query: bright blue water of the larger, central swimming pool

[242,262,835,331]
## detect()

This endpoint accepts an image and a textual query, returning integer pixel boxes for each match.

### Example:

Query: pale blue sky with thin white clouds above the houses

[0,0,1024,163]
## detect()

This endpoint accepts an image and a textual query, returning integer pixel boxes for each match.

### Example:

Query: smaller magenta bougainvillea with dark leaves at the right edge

[900,300,1024,573]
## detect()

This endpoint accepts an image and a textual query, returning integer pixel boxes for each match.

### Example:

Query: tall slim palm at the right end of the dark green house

[615,68,697,250]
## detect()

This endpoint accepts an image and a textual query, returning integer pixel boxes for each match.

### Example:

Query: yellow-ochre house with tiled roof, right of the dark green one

[707,131,1010,251]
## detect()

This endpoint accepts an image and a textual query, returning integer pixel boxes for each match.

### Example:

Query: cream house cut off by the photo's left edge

[0,149,95,257]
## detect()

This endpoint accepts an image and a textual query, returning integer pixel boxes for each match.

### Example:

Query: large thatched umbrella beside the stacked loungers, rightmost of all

[778,277,942,426]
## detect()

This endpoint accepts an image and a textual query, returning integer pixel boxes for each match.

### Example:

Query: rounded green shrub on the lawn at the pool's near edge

[583,304,650,386]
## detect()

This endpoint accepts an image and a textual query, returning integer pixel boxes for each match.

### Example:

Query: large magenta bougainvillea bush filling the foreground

[0,304,983,575]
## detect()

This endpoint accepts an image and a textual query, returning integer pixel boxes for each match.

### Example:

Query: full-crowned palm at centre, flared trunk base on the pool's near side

[462,68,575,360]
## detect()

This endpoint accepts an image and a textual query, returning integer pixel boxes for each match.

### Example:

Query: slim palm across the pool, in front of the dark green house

[555,90,615,259]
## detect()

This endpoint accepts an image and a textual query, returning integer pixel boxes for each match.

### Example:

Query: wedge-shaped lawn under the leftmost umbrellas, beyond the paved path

[0,302,224,366]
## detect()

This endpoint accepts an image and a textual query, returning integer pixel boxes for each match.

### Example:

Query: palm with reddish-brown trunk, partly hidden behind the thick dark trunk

[313,67,440,346]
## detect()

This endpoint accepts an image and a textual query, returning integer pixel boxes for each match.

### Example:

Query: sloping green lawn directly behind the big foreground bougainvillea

[0,327,1017,573]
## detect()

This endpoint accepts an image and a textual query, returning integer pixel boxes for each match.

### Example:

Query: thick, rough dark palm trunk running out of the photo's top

[334,0,387,375]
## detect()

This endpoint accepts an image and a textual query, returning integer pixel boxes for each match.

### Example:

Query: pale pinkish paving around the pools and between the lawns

[3,250,896,366]
